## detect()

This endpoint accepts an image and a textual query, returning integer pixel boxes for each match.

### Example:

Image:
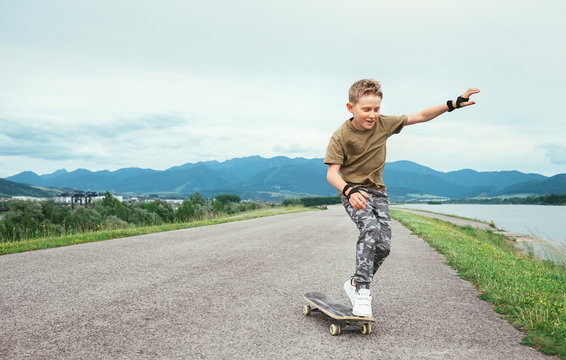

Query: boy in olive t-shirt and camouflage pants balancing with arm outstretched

[324,79,479,317]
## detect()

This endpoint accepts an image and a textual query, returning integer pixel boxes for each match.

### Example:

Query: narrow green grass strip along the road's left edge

[0,206,315,255]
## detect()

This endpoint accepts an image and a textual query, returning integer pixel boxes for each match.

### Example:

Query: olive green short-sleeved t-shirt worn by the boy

[324,115,407,194]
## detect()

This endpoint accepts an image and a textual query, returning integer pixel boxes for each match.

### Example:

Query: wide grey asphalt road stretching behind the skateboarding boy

[0,207,548,359]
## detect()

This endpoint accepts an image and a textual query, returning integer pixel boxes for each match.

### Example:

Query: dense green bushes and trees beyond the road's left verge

[0,192,267,243]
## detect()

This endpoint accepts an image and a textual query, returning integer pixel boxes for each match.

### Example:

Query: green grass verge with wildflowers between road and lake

[391,210,566,359]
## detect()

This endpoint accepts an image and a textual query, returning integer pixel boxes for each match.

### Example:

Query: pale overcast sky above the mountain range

[0,0,566,177]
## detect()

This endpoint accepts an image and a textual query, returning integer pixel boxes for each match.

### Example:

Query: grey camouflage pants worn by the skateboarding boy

[341,188,391,289]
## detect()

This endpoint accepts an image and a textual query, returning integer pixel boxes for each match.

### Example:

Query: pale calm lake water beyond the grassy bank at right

[394,204,566,263]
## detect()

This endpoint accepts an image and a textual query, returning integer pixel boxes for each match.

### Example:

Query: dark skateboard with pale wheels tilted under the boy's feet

[303,292,376,336]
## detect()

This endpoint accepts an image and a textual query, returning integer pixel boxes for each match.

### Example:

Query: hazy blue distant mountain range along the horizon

[0,156,566,201]
